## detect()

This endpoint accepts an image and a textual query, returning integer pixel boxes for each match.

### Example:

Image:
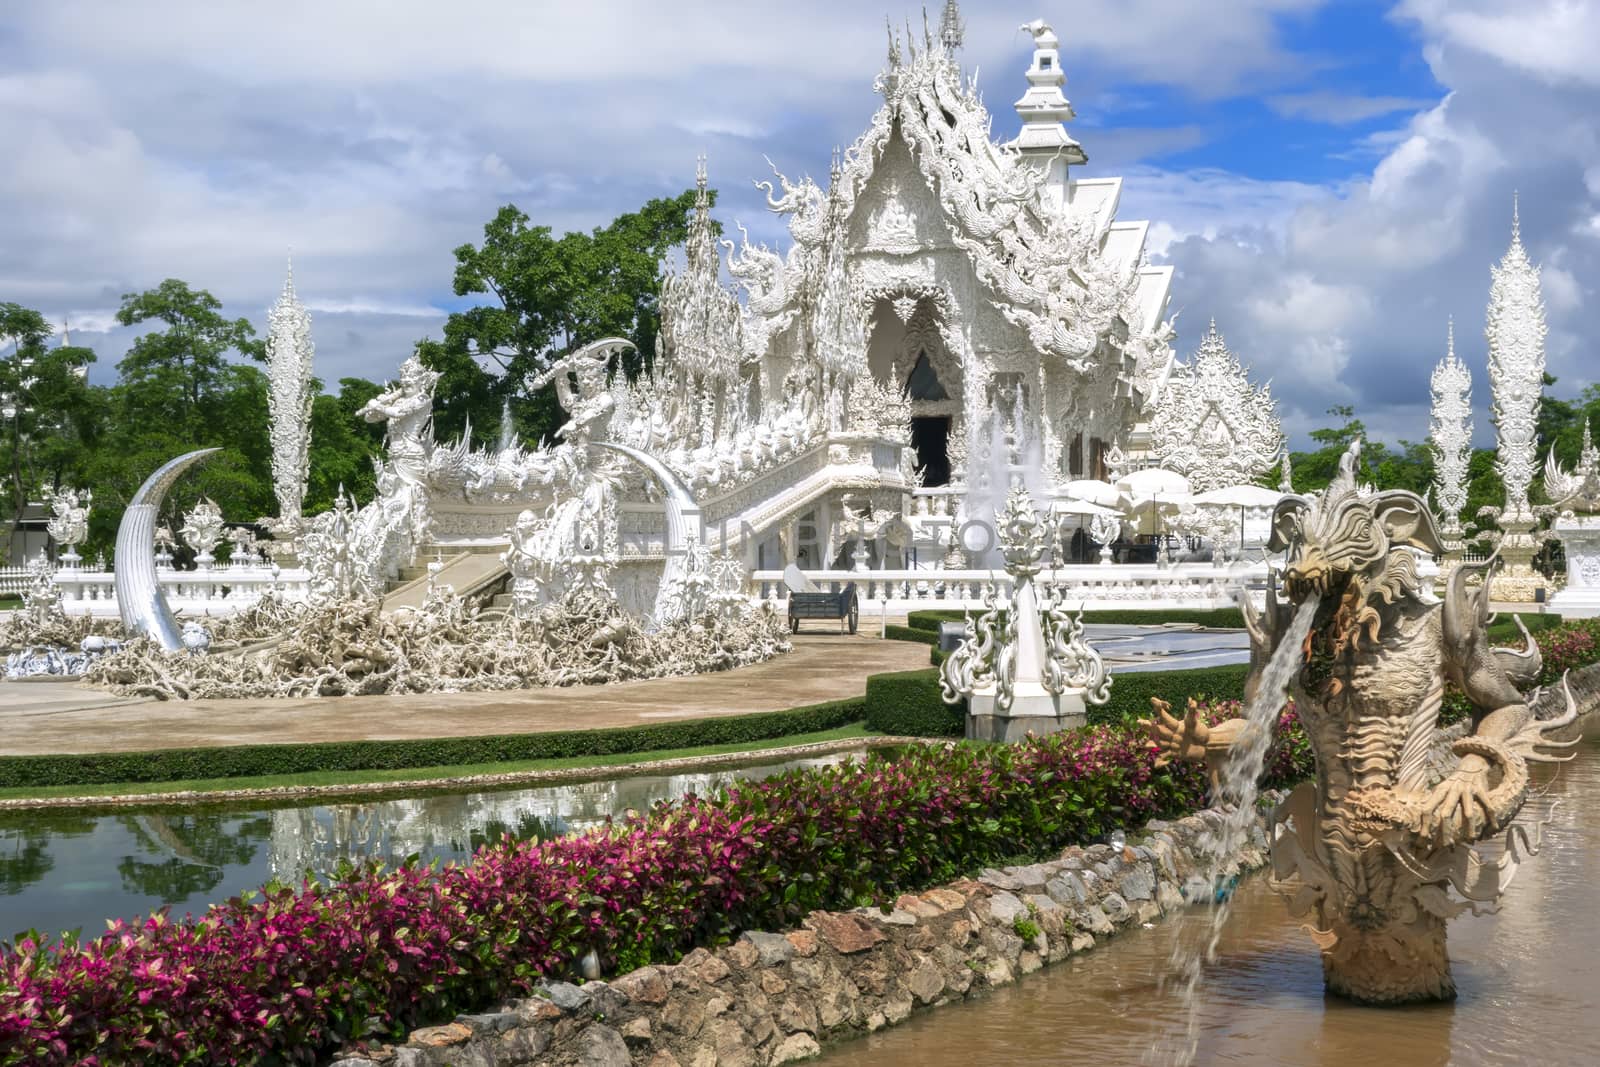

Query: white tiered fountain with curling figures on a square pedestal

[939,486,1112,741]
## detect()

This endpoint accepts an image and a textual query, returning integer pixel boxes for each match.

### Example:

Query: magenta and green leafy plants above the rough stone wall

[0,705,1310,1064]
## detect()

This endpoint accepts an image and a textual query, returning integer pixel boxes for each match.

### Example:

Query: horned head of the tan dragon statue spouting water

[1267,438,1443,648]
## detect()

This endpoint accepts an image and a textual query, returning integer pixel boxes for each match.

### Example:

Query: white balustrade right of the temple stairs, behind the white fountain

[749,563,1267,611]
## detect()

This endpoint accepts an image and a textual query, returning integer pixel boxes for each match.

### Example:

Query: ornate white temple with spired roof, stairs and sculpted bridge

[46,3,1282,611]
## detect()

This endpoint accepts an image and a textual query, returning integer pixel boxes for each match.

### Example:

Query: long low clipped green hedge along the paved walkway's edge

[0,697,866,787]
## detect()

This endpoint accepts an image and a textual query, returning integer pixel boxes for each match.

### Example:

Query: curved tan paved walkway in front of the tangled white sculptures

[0,633,928,755]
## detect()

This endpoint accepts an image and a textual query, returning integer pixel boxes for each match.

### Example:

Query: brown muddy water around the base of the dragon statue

[822,735,1600,1067]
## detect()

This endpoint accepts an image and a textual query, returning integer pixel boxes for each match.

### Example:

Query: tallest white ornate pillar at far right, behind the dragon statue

[1485,203,1546,601]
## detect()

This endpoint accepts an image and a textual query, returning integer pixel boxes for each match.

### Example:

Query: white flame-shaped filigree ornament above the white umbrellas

[1150,320,1283,493]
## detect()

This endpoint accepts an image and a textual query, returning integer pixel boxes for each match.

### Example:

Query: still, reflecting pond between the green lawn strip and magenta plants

[0,752,862,939]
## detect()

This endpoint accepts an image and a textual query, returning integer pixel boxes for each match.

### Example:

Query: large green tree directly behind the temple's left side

[418,190,715,442]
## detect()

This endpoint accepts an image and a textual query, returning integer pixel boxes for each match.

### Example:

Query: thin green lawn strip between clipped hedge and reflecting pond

[0,723,872,800]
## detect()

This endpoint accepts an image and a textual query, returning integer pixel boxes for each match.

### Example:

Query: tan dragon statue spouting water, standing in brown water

[1144,442,1578,1003]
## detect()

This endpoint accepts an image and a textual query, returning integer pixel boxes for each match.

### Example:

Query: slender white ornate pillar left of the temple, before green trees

[267,255,314,536]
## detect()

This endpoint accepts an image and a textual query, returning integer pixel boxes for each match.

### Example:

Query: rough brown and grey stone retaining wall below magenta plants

[334,793,1278,1067]
